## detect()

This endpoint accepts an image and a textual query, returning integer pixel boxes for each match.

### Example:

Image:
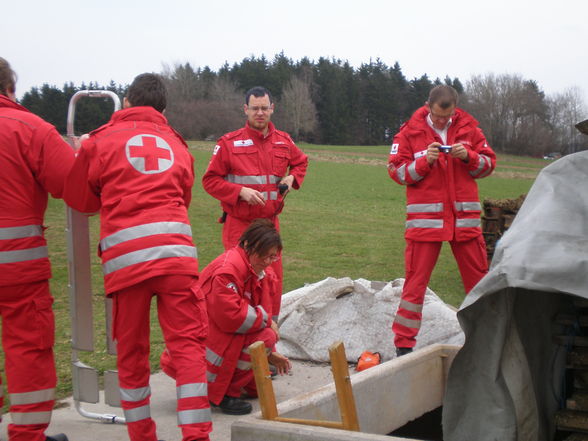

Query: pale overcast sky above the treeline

[0,0,588,106]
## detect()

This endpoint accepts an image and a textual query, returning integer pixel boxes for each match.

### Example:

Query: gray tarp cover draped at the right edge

[443,152,588,441]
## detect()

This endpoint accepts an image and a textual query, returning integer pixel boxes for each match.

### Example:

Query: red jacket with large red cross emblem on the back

[64,107,198,294]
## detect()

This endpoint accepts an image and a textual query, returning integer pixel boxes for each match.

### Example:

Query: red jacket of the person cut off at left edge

[0,95,74,286]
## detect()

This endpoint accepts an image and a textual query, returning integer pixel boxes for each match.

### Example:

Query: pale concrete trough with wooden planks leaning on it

[231,344,460,441]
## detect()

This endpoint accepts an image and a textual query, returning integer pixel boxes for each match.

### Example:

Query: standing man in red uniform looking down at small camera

[388,85,496,355]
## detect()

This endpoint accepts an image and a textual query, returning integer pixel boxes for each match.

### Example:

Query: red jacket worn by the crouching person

[198,246,275,403]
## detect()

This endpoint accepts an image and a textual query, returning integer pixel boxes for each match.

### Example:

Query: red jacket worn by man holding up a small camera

[388,107,496,241]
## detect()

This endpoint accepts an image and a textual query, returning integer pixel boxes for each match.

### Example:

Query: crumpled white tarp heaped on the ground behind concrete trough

[277,277,463,362]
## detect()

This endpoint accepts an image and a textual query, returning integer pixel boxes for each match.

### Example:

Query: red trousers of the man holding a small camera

[392,236,488,348]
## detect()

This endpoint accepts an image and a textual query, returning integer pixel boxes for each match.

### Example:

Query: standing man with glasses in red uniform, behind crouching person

[202,87,308,322]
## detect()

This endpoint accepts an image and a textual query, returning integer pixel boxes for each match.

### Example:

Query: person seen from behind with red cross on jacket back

[64,74,212,441]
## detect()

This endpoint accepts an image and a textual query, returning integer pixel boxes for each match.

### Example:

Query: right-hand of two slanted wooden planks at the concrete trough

[329,341,359,432]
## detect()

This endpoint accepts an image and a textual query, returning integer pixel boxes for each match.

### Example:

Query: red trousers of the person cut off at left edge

[0,280,57,441]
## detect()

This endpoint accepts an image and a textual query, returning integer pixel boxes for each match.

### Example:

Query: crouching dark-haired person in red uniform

[161,219,290,415]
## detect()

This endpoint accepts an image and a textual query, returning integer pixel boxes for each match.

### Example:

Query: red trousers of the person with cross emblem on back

[113,275,212,441]
